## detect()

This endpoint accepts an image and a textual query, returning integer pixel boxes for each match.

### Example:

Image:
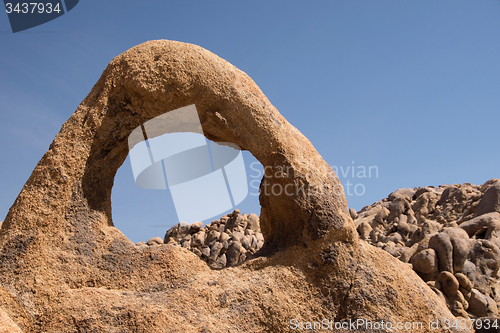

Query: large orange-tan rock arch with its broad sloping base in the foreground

[0,41,468,332]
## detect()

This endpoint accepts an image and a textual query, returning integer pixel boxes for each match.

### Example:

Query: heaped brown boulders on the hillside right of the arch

[350,179,500,318]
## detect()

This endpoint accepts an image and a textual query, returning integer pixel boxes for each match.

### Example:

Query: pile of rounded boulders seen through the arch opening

[136,209,264,269]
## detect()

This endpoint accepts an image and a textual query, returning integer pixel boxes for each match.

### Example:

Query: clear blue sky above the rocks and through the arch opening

[0,0,500,242]
